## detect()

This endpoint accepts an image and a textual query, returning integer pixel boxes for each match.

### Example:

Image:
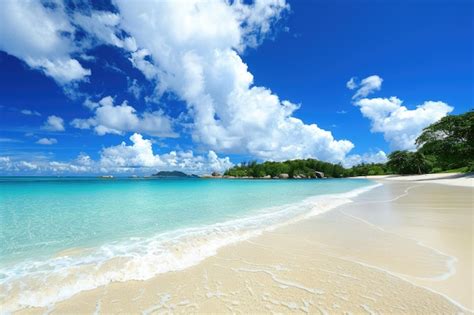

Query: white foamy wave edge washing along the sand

[0,184,380,312]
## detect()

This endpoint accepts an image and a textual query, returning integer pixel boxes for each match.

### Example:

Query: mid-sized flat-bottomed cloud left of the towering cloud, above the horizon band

[71,96,177,137]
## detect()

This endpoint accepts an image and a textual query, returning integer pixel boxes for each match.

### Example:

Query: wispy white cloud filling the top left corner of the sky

[0,0,91,84]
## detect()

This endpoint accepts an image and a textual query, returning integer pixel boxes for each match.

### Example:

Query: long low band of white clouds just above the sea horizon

[0,133,234,175]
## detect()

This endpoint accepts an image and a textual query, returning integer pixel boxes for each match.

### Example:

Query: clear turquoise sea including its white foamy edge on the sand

[0,177,373,312]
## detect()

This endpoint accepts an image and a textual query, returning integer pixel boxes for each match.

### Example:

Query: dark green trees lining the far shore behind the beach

[224,111,474,178]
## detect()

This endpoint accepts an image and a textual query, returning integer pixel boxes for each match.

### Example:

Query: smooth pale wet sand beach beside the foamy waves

[16,180,474,314]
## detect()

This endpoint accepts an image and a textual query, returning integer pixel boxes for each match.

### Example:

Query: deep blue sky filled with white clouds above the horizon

[0,0,474,175]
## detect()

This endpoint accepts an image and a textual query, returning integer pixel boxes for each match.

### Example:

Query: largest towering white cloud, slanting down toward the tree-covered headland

[111,0,353,161]
